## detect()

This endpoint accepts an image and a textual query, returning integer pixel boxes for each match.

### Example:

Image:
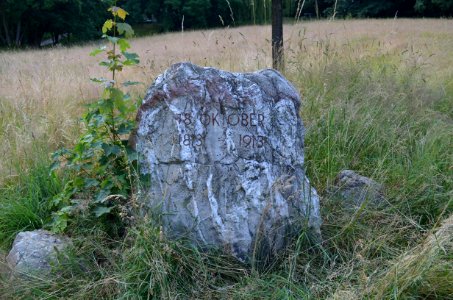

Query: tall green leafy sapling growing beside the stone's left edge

[51,2,139,232]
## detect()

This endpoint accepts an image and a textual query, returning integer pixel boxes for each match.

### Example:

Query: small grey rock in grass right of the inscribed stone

[334,170,384,208]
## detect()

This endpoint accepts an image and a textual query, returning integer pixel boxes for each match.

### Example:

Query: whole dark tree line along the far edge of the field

[0,0,453,47]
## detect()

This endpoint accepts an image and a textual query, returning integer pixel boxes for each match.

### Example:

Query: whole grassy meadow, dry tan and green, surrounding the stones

[0,19,453,299]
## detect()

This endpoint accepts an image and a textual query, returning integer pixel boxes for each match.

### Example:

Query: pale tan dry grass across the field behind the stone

[0,20,453,183]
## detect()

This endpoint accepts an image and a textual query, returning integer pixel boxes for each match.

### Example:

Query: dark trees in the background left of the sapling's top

[0,0,108,47]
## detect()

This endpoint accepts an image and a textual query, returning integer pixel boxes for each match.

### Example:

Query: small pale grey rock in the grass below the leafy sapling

[6,230,70,275]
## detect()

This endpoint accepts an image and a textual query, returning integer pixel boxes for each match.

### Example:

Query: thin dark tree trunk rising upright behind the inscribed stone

[272,0,284,71]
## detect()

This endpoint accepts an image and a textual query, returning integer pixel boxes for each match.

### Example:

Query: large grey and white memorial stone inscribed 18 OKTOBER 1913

[135,63,321,261]
